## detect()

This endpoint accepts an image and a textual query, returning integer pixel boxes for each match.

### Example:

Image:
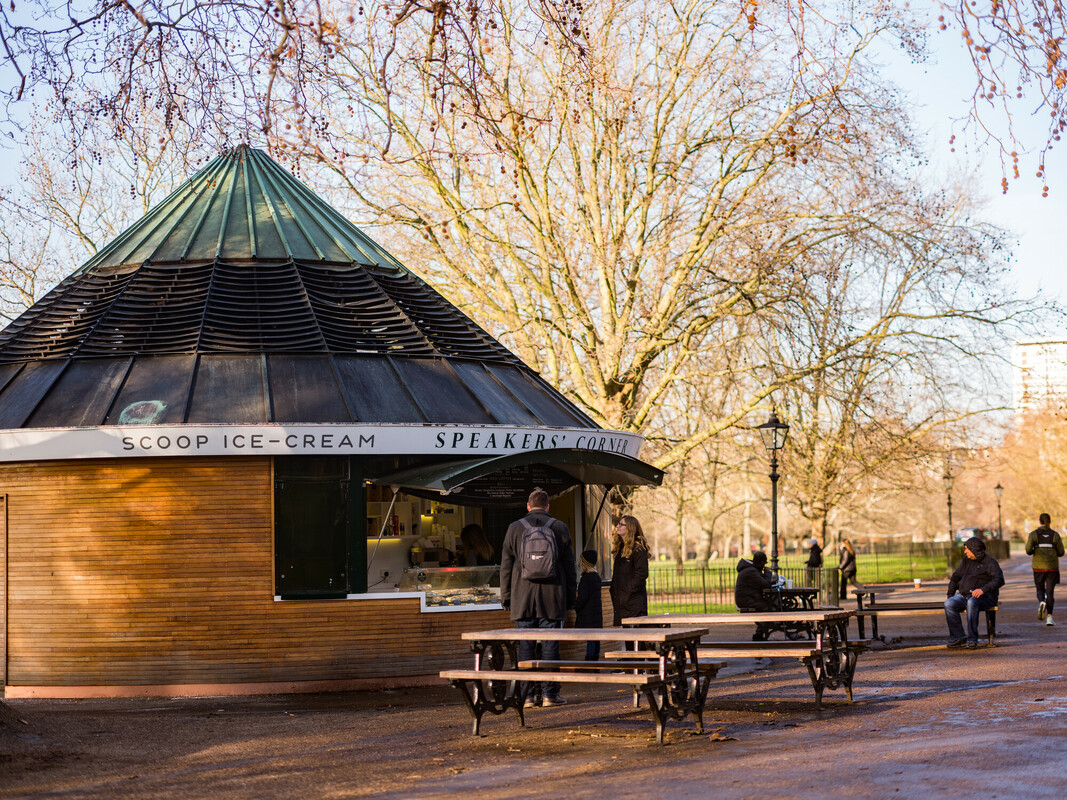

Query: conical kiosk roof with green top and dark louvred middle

[0,146,596,430]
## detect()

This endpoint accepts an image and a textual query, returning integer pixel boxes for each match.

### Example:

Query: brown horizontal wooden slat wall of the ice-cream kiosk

[0,458,511,686]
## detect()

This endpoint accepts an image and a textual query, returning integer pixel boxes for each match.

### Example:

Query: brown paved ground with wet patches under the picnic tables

[0,558,1067,800]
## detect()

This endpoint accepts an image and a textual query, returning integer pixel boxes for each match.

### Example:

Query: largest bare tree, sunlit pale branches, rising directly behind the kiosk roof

[279,1,1011,465]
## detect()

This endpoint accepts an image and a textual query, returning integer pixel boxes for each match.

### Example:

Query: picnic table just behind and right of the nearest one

[623,608,869,708]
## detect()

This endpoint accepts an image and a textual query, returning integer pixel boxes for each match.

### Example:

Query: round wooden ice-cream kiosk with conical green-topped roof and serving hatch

[0,146,663,697]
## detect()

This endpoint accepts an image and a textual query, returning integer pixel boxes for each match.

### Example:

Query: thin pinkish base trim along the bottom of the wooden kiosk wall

[3,675,445,700]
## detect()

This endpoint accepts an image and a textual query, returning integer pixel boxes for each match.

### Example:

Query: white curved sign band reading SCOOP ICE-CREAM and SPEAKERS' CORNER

[0,425,644,462]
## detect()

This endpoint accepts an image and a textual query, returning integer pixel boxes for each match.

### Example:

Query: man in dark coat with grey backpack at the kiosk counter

[500,489,577,708]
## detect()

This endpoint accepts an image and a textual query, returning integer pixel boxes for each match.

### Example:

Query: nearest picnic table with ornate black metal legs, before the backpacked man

[441,626,726,745]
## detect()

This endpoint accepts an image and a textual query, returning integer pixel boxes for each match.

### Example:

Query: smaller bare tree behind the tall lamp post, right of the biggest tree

[762,167,1034,541]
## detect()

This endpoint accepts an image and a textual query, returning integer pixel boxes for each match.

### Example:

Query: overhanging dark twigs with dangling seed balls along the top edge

[0,0,1067,188]
